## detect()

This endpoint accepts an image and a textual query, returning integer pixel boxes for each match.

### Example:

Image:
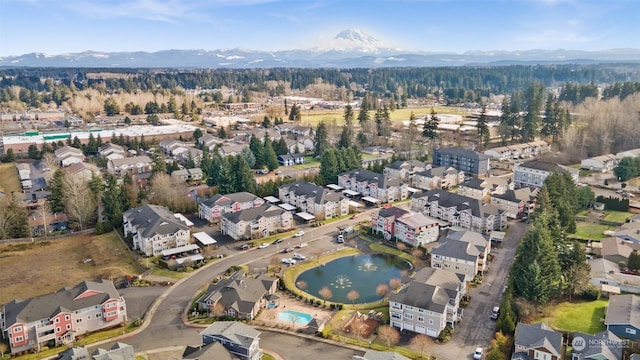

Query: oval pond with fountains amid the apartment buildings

[295,254,411,304]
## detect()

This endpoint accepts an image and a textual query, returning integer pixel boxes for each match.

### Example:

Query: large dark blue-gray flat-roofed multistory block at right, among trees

[433,147,489,178]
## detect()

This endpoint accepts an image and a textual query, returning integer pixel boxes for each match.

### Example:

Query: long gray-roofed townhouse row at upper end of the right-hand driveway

[411,190,507,233]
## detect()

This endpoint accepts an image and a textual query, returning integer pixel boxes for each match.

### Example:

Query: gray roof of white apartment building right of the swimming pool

[389,281,458,313]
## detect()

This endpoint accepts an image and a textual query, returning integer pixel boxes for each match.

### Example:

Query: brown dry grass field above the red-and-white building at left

[0,232,141,304]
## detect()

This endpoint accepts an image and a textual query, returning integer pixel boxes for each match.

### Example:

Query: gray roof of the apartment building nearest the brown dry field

[124,205,189,238]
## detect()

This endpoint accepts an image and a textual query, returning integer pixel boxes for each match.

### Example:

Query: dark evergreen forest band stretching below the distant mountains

[0,64,640,103]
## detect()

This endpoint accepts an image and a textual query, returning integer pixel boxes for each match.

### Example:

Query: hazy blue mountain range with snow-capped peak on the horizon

[0,29,640,68]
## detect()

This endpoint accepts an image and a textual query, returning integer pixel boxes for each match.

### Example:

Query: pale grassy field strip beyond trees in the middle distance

[302,106,468,126]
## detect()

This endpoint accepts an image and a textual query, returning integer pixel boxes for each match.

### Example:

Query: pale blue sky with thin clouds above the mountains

[0,0,640,56]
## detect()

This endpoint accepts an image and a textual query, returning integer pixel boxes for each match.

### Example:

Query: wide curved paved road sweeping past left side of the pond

[92,212,370,352]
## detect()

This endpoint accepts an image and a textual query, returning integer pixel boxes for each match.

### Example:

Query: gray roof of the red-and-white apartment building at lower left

[4,280,120,327]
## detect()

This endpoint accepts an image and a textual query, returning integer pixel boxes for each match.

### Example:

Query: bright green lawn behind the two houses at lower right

[536,299,609,334]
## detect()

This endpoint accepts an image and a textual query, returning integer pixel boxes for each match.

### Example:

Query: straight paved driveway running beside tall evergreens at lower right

[433,221,527,360]
